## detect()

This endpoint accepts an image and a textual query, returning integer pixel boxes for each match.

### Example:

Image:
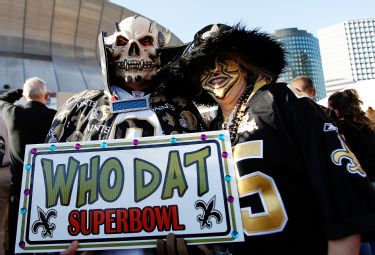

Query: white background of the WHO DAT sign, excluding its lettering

[16,132,243,252]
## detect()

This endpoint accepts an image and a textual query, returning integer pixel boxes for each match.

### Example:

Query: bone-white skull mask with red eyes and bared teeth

[105,16,170,83]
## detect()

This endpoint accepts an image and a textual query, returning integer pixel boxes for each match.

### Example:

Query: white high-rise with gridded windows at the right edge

[318,18,375,94]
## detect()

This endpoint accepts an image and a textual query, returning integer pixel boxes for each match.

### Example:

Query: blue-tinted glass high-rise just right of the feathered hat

[273,28,326,100]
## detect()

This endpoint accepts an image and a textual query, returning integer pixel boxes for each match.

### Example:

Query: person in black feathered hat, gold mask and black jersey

[168,22,375,255]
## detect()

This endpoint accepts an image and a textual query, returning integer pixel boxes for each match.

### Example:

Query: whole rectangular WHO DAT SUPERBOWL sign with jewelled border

[16,131,243,253]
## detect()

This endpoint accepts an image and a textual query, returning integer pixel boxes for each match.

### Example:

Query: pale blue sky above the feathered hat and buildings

[110,0,375,42]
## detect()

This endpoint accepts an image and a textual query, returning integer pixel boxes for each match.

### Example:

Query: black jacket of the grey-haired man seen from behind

[0,89,56,195]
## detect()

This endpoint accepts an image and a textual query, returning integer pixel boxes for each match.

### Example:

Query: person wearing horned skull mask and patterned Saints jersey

[46,16,204,143]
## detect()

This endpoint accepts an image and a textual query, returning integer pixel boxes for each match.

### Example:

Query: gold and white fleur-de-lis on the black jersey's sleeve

[331,135,366,177]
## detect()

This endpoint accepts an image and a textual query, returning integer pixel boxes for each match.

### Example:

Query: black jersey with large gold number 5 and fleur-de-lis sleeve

[219,83,375,255]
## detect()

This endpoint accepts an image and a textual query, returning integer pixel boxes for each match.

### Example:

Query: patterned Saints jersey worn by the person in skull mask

[46,90,209,143]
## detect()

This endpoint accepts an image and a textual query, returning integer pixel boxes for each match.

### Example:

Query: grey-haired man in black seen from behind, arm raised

[0,77,56,254]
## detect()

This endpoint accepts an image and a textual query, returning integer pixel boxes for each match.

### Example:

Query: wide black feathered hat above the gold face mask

[162,24,286,101]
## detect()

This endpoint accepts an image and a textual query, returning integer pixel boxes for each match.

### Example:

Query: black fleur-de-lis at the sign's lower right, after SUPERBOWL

[195,196,223,229]
